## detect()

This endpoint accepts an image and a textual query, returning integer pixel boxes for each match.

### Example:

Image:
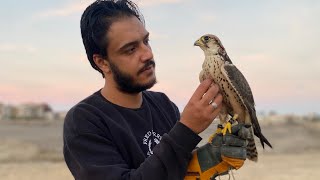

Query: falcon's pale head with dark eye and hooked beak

[194,34,225,54]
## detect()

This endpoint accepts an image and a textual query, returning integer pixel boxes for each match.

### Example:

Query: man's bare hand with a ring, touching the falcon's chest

[180,79,222,134]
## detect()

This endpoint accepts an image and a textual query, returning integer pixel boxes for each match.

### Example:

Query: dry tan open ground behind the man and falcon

[0,121,320,180]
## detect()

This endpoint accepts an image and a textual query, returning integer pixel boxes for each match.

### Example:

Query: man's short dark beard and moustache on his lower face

[109,60,157,94]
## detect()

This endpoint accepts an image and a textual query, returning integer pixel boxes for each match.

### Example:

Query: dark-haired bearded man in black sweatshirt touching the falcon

[63,0,245,180]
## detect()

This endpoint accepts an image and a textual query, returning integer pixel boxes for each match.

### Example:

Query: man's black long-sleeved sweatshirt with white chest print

[63,91,201,180]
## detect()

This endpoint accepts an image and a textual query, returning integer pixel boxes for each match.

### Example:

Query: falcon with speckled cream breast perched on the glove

[194,34,272,161]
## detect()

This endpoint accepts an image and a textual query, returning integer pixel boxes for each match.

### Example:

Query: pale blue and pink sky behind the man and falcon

[0,0,320,114]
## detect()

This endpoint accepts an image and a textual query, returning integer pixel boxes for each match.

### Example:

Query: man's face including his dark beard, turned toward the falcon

[107,17,156,94]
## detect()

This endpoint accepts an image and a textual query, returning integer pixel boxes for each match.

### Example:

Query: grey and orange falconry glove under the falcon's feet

[184,124,248,180]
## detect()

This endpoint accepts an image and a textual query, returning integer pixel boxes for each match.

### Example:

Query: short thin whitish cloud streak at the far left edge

[0,43,38,53]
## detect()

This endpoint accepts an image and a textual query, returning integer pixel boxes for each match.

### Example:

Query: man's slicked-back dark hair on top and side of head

[80,0,144,77]
